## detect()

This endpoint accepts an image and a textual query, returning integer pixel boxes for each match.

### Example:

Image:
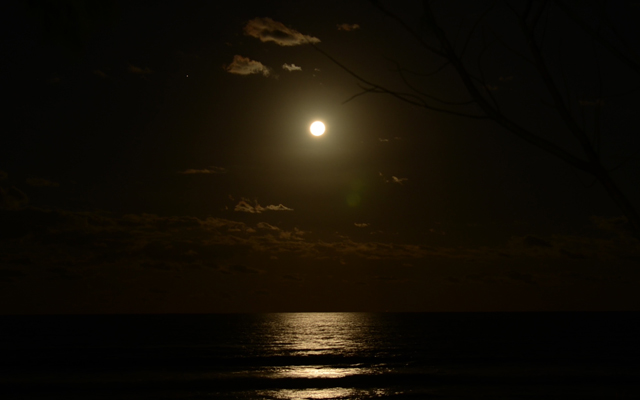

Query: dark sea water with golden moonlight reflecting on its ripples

[0,313,640,400]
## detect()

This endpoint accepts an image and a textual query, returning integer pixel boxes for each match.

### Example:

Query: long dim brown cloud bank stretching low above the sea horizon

[0,202,640,294]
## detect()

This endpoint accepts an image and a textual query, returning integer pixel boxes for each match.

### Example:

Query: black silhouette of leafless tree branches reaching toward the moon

[314,0,640,238]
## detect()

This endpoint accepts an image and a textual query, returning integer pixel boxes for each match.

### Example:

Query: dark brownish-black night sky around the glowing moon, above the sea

[0,0,640,314]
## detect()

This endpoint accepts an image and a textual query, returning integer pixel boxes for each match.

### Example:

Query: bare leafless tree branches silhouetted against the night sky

[314,0,640,238]
